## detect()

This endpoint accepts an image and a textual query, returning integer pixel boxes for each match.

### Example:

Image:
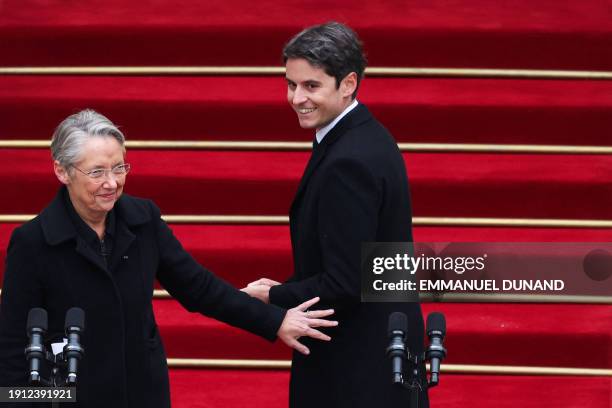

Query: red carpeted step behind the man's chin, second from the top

[0,75,612,146]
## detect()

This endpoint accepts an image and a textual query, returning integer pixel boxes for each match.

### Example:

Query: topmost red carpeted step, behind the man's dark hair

[0,0,612,70]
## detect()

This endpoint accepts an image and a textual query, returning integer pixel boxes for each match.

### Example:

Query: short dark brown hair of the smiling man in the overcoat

[283,21,368,99]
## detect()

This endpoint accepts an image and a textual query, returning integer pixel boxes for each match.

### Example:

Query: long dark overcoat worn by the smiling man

[270,104,427,408]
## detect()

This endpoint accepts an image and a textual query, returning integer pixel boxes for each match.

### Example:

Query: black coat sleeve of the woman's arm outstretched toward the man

[151,203,286,341]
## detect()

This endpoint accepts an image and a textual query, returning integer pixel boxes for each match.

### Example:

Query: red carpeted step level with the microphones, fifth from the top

[154,299,612,368]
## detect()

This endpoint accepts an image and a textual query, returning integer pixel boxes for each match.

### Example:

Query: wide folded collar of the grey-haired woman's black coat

[40,186,151,245]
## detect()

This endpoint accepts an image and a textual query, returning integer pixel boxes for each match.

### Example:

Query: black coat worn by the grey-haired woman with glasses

[0,187,284,408]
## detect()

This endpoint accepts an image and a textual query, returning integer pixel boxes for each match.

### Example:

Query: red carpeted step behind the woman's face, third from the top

[0,149,612,219]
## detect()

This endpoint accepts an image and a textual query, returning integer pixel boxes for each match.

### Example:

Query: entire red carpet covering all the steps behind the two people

[0,0,612,408]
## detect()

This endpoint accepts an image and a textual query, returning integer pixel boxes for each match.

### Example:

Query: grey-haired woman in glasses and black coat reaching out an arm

[0,110,336,408]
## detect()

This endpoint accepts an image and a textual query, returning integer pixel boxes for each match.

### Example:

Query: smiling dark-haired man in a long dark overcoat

[243,22,428,408]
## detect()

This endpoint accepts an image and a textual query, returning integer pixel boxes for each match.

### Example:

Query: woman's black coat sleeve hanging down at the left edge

[0,228,43,388]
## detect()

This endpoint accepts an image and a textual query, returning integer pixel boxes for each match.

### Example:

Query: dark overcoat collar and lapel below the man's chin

[291,103,372,211]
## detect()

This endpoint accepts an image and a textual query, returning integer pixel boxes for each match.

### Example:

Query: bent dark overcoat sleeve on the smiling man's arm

[270,159,382,310]
